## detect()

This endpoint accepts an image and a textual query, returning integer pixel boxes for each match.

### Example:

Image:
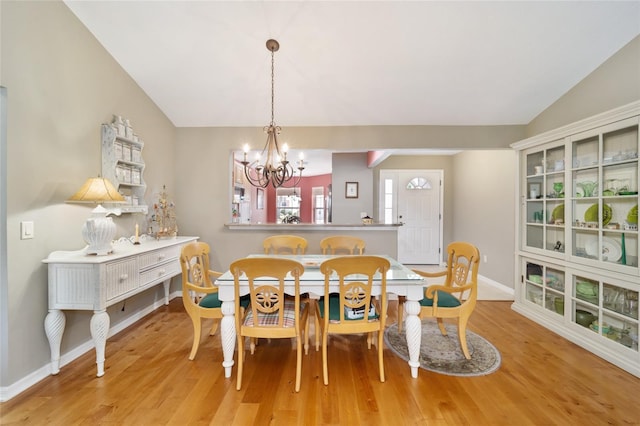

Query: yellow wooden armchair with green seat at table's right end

[398,242,480,359]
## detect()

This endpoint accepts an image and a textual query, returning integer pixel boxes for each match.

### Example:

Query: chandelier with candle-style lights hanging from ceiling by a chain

[241,39,304,188]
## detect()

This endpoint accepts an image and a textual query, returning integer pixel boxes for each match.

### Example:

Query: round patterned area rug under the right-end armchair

[384,320,501,376]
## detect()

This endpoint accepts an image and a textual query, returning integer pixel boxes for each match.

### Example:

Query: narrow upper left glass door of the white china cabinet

[523,142,565,253]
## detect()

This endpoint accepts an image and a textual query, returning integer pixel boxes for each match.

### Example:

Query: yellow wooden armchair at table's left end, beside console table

[180,242,222,360]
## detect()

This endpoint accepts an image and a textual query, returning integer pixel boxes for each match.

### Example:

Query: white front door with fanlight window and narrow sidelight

[379,170,443,265]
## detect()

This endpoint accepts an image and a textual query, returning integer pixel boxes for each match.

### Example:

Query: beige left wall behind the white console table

[0,1,175,389]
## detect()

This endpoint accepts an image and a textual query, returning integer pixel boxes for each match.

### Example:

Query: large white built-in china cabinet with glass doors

[512,101,640,377]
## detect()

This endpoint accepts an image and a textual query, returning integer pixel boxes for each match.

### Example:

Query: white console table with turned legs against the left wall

[43,237,198,377]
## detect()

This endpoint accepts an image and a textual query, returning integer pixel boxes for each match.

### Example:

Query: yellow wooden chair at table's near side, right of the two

[316,256,390,385]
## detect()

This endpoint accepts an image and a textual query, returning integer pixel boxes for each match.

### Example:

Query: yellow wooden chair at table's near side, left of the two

[230,258,309,392]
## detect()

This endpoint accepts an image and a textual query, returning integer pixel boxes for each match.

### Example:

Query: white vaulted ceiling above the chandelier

[66,0,640,127]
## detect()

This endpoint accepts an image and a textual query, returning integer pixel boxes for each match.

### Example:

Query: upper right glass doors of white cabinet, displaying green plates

[568,119,638,269]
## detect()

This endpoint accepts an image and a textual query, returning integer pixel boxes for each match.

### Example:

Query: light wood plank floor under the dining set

[0,299,640,426]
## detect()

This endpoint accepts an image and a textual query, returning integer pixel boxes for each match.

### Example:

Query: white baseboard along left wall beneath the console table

[0,291,182,402]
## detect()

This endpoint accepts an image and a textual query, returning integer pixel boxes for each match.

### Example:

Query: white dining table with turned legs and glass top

[216,254,425,378]
